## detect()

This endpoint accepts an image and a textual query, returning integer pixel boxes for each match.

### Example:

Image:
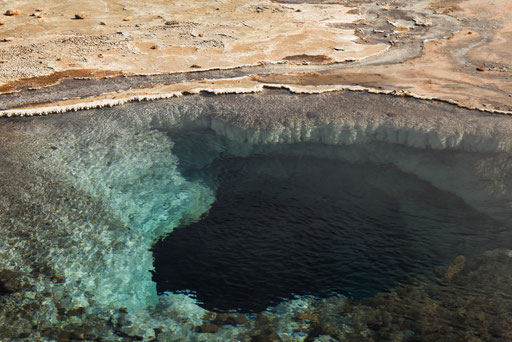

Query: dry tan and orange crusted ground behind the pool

[0,0,512,115]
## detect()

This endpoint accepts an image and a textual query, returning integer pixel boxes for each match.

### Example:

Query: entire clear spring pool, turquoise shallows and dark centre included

[0,90,512,342]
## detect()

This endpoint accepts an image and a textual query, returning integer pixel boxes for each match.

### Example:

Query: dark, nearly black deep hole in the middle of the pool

[153,150,499,312]
